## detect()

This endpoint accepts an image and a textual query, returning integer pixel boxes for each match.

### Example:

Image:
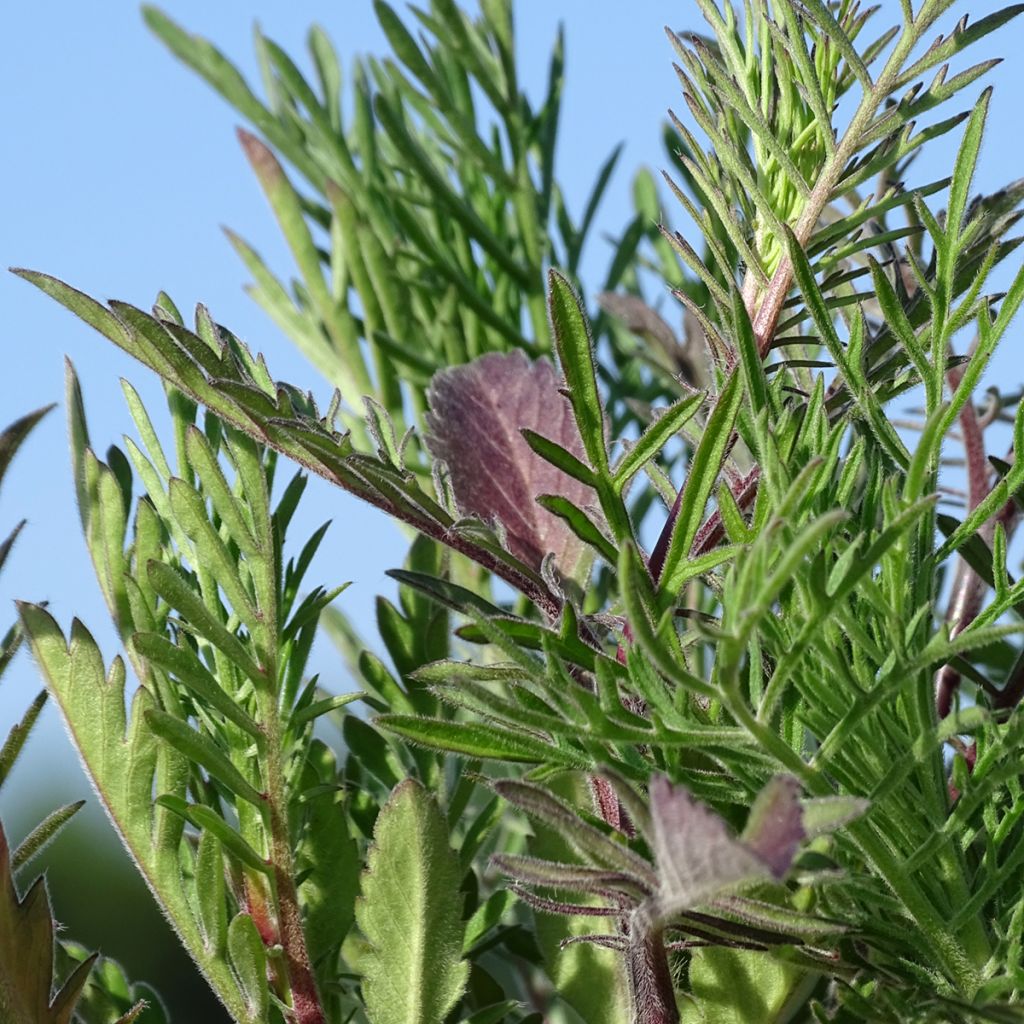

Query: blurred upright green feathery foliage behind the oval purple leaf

[137,0,636,448]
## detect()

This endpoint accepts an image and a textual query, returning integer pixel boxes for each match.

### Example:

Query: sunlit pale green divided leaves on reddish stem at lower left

[22,362,368,1021]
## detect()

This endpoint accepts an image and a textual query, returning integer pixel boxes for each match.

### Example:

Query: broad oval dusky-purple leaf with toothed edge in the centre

[426,350,594,575]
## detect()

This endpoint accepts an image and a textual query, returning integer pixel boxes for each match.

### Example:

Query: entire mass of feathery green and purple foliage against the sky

[9,0,1024,1024]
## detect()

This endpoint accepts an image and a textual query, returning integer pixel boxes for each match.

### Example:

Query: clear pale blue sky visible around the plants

[0,0,1024,827]
